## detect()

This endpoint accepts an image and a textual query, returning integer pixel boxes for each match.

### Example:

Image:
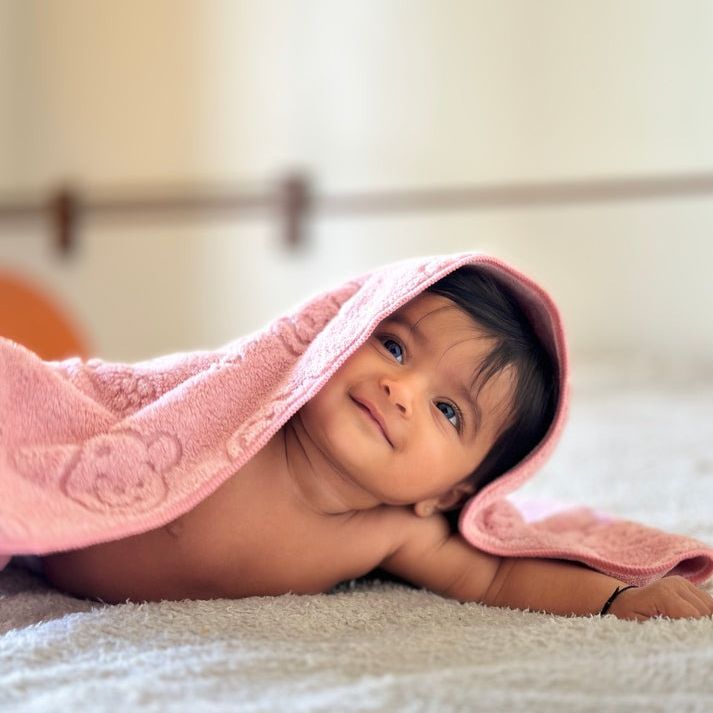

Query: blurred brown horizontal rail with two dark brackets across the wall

[0,173,713,254]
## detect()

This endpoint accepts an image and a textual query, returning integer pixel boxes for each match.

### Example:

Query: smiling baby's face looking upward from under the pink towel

[301,293,512,505]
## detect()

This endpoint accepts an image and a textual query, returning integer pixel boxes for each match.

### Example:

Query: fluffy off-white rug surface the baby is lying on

[0,365,713,713]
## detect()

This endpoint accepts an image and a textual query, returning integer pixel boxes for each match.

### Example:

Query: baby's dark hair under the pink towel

[427,266,559,532]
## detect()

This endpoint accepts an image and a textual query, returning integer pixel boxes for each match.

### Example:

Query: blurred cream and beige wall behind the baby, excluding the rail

[0,0,713,365]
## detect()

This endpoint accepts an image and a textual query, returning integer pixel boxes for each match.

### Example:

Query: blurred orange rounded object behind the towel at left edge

[0,272,88,360]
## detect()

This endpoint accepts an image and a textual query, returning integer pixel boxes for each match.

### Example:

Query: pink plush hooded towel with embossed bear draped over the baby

[0,253,713,584]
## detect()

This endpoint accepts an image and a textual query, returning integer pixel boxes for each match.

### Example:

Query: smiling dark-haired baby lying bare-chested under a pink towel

[42,266,713,620]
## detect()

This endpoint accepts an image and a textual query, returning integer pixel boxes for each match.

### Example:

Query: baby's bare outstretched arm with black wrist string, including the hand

[381,511,713,620]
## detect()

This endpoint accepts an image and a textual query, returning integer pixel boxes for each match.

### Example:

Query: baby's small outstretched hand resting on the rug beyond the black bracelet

[609,575,713,621]
